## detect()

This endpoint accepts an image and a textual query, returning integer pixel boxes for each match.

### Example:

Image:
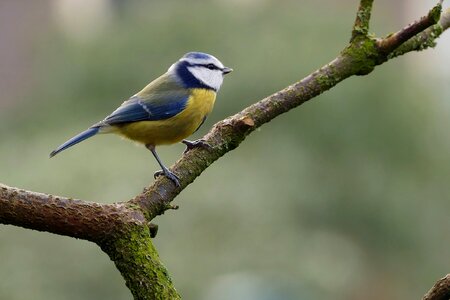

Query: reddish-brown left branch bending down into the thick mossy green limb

[0,184,179,299]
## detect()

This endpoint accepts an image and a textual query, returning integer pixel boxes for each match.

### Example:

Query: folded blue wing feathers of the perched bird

[102,94,189,125]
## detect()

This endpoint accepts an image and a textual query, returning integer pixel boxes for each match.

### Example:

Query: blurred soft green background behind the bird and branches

[0,0,450,300]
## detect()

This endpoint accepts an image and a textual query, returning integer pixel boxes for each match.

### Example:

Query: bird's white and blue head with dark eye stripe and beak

[168,52,233,92]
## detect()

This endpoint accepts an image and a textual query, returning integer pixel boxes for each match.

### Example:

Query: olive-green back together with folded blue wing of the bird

[102,76,189,125]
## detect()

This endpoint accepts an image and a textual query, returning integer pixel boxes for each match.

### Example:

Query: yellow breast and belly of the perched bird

[117,89,216,146]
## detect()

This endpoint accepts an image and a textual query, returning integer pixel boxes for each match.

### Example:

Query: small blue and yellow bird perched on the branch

[50,52,233,187]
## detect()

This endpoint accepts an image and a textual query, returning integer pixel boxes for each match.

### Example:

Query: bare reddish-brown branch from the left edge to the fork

[0,184,142,242]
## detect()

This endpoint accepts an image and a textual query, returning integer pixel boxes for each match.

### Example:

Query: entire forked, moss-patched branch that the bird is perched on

[0,0,450,300]
